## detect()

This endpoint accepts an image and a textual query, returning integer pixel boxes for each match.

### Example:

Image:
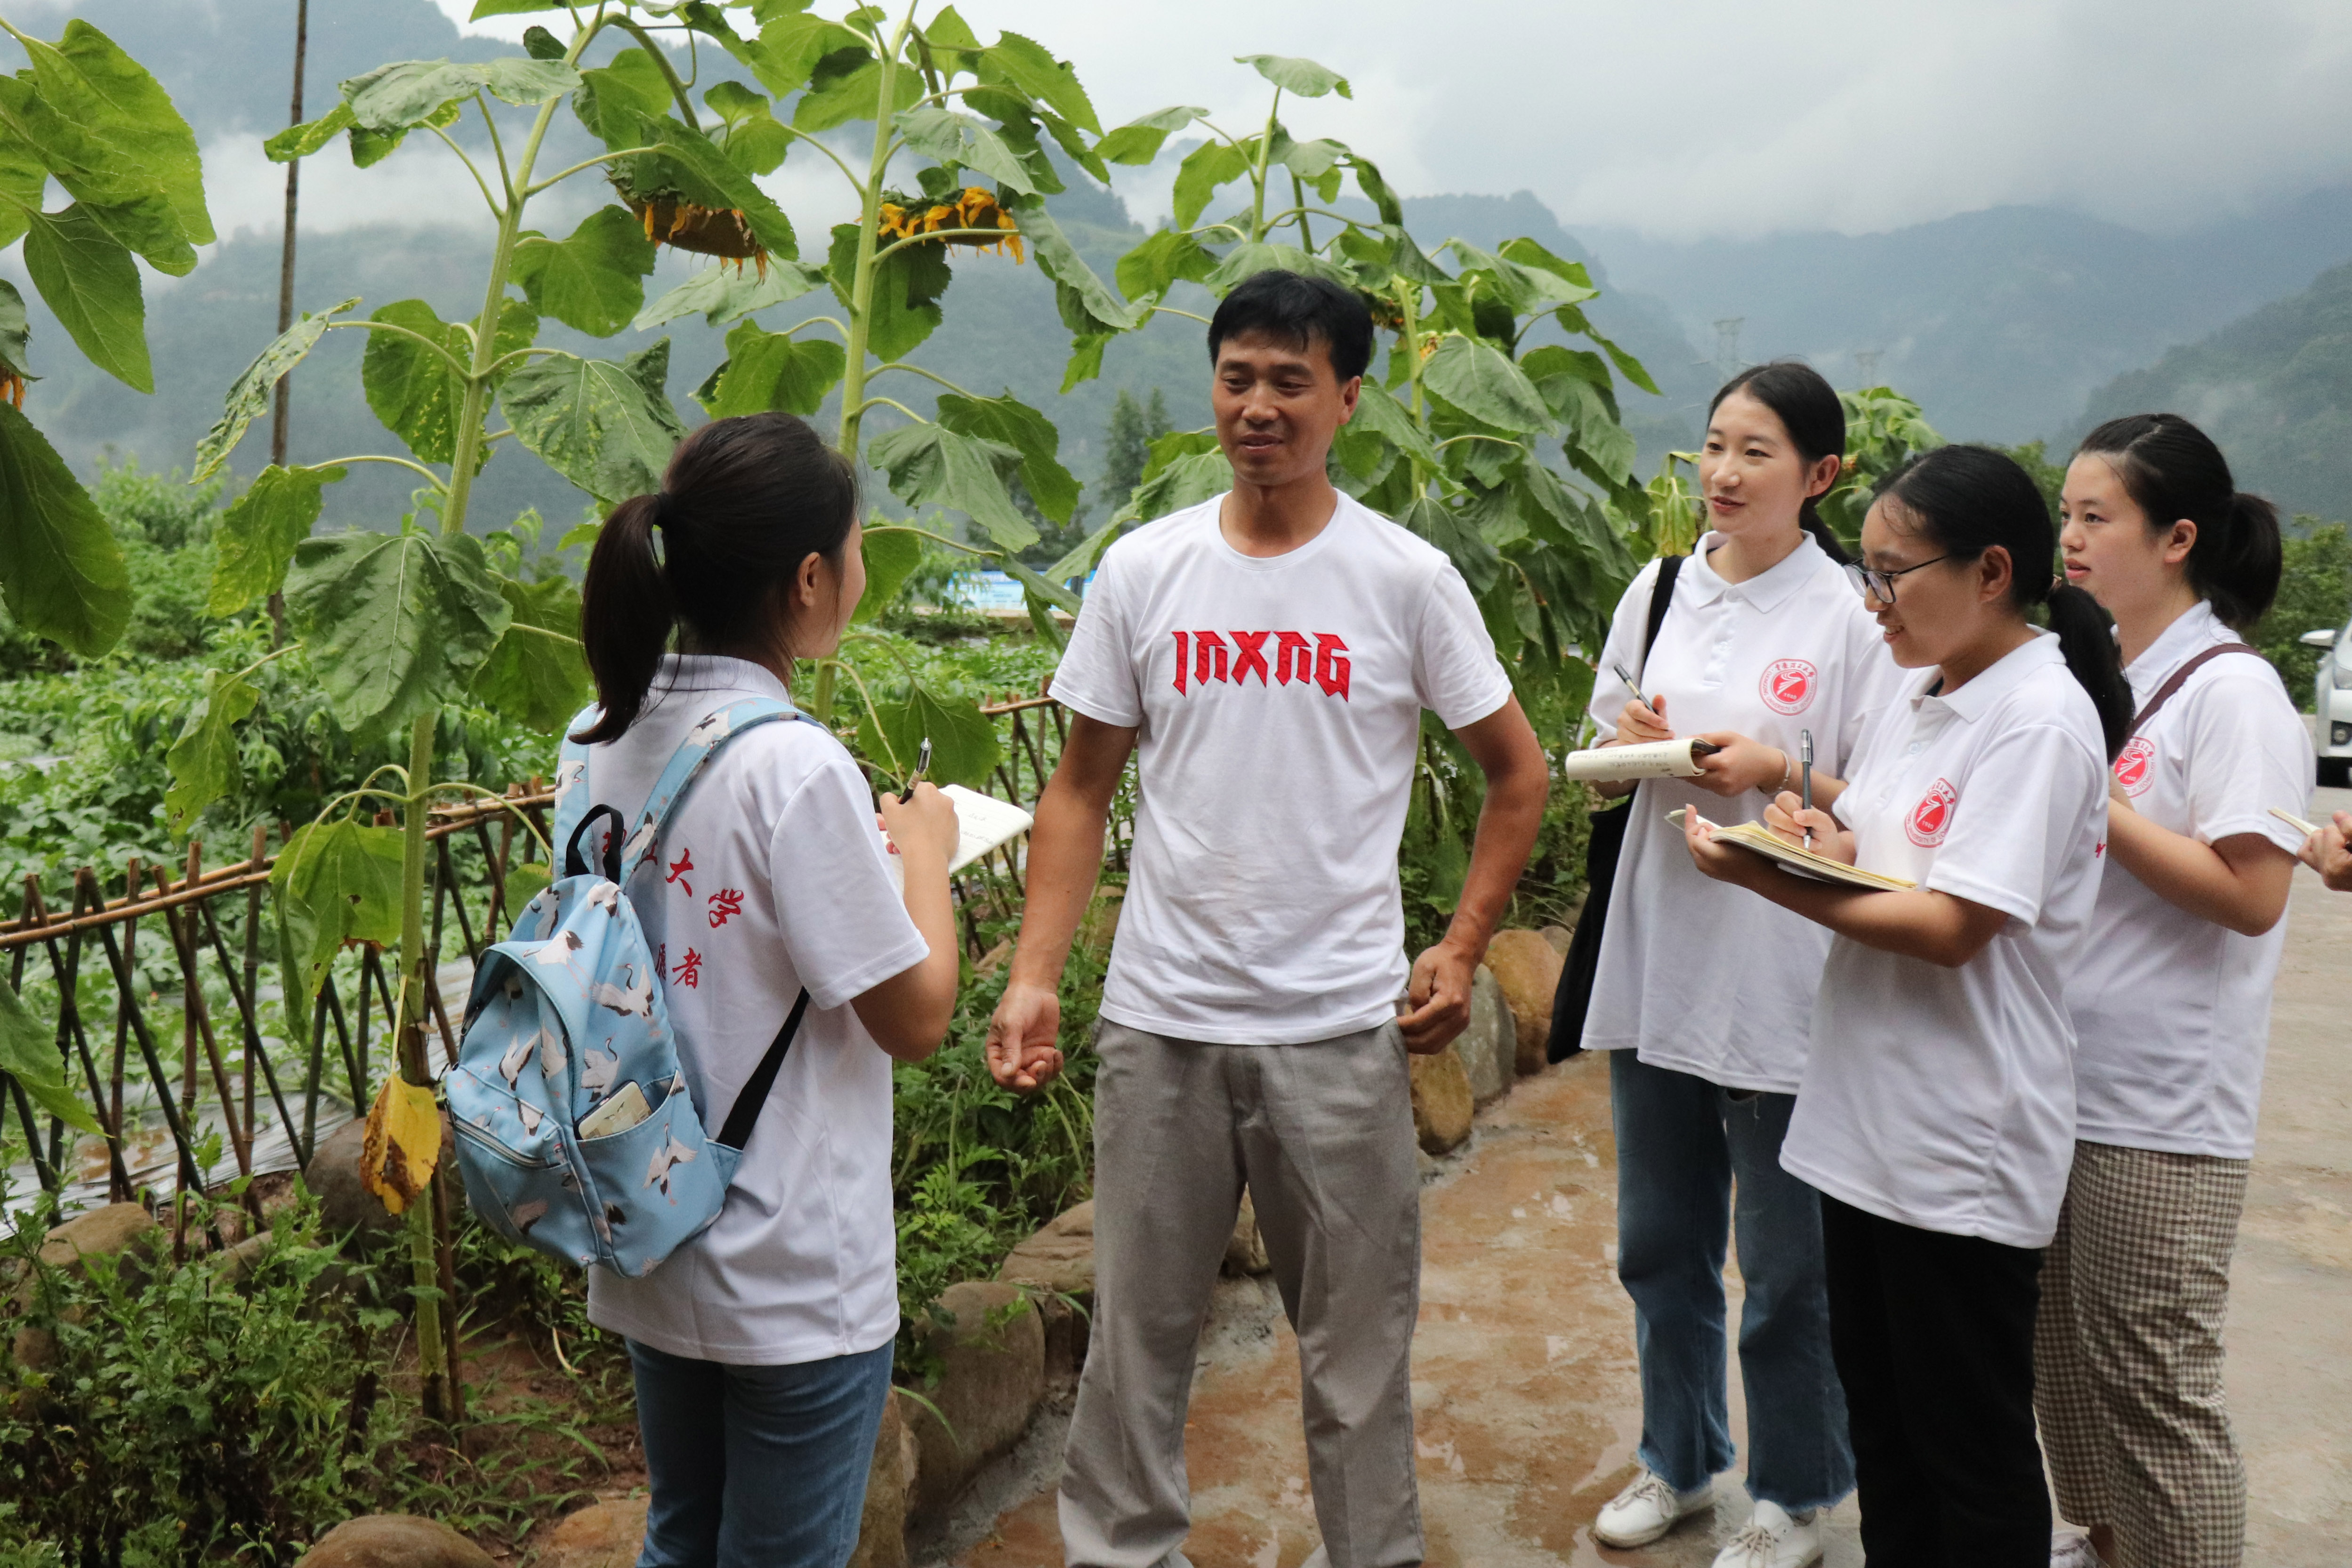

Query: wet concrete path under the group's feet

[952,790,2352,1568]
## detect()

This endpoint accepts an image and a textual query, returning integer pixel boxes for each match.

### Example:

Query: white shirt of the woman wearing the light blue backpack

[588,656,929,1366]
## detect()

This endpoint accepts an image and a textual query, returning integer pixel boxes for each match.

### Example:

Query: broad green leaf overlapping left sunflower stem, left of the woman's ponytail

[287,531,513,736]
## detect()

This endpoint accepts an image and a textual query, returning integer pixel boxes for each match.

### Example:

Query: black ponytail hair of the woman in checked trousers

[2074,414,2284,630]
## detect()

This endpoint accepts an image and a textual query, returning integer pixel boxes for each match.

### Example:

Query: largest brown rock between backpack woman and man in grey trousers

[901,1279,1044,1519]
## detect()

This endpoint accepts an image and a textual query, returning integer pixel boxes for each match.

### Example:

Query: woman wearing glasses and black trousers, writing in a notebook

[1686,447,2131,1568]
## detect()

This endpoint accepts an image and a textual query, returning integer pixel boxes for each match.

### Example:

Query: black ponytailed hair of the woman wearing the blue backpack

[572,414,859,743]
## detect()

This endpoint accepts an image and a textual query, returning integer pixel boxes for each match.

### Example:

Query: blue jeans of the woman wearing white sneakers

[1609,1051,1853,1514]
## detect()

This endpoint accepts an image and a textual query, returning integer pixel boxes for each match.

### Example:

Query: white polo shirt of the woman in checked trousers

[2067,602,2312,1159]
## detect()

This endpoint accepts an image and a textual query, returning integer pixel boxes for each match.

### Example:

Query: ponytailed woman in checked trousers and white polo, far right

[2035,414,2312,1568]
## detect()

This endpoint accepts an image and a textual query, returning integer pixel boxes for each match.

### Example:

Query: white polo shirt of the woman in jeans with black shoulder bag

[1585,534,1903,1093]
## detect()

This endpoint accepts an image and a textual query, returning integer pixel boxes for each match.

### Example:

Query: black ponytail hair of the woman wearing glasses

[1877,447,2131,762]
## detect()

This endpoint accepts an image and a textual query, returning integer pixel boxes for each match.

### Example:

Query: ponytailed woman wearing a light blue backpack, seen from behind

[574,414,957,1568]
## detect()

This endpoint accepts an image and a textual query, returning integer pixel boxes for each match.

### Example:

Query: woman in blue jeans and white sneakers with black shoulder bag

[1583,364,1901,1568]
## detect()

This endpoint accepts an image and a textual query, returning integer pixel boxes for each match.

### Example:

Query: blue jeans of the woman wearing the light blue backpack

[628,1340,891,1568]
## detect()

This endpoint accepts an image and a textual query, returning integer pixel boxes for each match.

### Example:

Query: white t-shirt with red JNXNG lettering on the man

[1054,496,1510,1044]
